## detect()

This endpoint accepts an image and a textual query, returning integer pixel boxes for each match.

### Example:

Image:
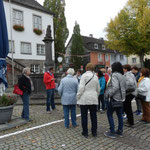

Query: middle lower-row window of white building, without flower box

[21,42,31,54]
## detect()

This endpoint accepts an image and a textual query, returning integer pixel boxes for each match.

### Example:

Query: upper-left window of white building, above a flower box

[13,9,23,26]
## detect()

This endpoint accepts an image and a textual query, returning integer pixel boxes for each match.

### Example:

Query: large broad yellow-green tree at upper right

[106,0,150,66]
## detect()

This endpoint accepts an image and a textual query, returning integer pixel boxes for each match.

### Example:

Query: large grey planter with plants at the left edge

[0,95,17,124]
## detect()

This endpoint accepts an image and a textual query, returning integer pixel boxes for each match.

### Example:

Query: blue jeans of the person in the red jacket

[46,89,55,111]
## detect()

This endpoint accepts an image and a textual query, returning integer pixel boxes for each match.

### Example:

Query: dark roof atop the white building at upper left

[4,0,53,15]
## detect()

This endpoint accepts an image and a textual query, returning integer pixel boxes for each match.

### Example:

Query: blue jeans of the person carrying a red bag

[21,93,29,120]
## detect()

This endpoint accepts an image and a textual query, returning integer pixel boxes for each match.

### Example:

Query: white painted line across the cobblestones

[0,114,81,139]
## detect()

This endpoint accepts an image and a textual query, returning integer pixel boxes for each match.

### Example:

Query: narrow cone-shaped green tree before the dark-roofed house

[71,22,84,69]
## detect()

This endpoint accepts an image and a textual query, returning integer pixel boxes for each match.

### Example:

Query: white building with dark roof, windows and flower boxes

[4,0,54,73]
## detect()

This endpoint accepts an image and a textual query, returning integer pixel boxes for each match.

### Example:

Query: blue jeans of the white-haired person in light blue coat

[63,105,77,128]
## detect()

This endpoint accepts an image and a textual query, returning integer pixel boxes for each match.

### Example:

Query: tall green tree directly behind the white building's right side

[44,0,69,63]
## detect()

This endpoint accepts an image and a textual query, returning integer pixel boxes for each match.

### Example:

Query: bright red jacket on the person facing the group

[43,72,55,90]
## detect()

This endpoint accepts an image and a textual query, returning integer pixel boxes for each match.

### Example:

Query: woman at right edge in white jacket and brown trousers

[137,68,150,124]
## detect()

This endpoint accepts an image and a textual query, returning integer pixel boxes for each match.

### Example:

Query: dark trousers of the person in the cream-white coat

[80,105,97,135]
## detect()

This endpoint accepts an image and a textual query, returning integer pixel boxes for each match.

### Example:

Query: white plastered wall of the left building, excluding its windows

[4,1,54,60]
